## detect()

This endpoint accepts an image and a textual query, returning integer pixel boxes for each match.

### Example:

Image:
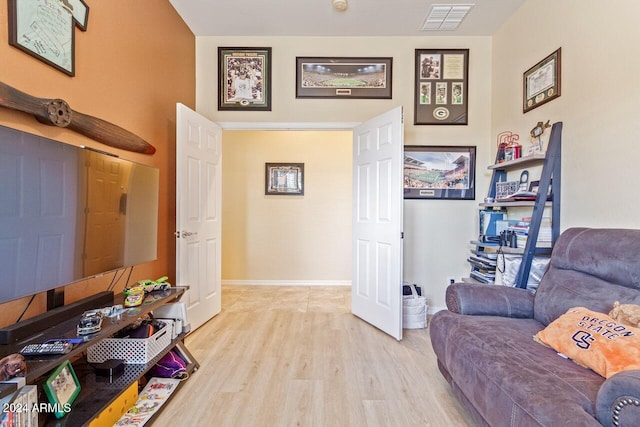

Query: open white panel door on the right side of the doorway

[351,107,404,340]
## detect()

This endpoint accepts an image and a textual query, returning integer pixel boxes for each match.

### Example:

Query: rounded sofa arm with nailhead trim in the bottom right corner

[596,370,640,427]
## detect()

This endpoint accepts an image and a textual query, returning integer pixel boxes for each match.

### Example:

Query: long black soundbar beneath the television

[0,291,113,346]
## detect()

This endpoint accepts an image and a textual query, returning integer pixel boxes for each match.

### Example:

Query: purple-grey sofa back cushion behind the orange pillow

[534,228,640,326]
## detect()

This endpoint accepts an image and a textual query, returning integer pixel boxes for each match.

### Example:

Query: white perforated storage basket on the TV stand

[87,320,173,365]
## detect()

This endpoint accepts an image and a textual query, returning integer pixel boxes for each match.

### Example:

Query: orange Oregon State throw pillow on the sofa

[533,307,640,378]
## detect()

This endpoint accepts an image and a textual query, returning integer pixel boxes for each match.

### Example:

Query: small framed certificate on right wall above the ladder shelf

[522,48,561,113]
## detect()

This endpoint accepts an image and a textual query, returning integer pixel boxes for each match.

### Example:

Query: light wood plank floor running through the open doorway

[155,286,473,427]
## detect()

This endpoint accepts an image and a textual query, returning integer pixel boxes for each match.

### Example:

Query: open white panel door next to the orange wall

[176,103,222,330]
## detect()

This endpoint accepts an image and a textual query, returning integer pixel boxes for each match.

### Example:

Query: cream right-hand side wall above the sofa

[491,0,640,230]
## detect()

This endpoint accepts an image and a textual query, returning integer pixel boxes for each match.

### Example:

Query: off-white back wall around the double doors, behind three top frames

[196,37,495,307]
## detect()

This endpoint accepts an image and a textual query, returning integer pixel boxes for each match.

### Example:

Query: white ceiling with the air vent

[169,0,525,36]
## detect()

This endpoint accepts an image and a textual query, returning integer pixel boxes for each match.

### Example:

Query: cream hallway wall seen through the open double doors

[222,130,353,286]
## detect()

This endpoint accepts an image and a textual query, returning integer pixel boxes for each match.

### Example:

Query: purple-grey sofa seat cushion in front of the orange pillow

[429,310,604,427]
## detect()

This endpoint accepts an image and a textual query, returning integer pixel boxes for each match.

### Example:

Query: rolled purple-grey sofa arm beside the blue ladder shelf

[446,283,534,319]
